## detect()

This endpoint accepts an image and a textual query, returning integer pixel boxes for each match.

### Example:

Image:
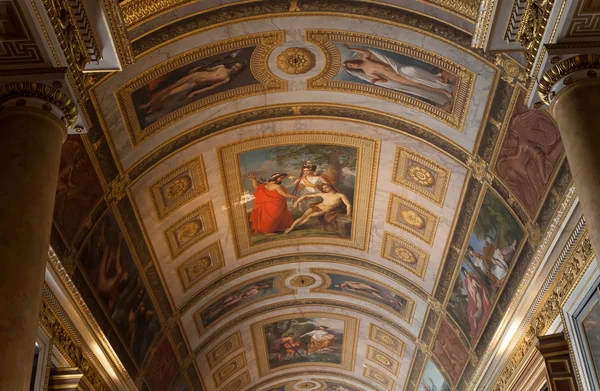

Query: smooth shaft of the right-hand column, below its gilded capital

[552,79,600,264]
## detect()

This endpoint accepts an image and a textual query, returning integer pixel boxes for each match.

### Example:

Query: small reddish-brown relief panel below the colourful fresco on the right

[433,320,469,383]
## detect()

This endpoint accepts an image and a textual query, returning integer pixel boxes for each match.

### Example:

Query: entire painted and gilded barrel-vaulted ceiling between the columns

[45,0,570,391]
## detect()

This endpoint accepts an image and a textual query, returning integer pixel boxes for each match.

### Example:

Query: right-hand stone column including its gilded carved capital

[538,55,600,264]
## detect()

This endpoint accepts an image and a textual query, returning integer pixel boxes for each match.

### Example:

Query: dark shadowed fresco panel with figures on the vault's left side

[80,210,160,363]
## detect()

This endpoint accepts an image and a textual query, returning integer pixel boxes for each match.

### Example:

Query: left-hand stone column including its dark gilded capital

[0,82,76,391]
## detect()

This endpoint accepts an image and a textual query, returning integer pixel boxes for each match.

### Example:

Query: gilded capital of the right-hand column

[534,53,600,108]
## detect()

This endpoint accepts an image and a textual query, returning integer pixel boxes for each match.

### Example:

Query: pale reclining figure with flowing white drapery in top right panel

[344,44,453,106]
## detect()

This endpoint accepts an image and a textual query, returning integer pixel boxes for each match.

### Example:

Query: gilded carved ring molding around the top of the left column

[0,81,77,127]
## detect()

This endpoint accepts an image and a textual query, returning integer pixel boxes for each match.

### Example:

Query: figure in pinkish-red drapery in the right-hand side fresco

[460,267,492,342]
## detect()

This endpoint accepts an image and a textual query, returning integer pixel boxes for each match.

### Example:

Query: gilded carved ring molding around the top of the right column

[537,53,600,104]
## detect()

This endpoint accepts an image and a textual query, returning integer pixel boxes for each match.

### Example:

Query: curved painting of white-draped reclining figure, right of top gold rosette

[334,42,454,111]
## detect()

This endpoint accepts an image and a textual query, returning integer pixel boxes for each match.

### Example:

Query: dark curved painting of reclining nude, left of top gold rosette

[131,47,257,128]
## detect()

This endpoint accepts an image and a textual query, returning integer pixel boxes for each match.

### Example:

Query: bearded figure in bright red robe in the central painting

[248,172,298,235]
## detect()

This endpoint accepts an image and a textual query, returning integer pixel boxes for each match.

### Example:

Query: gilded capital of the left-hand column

[0,81,78,137]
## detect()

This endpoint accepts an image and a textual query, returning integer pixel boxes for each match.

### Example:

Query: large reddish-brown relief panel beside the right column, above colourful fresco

[496,96,563,213]
